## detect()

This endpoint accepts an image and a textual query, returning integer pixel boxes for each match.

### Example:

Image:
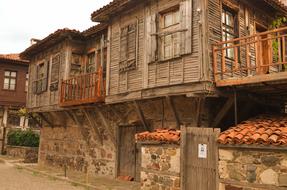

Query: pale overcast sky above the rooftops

[0,0,111,54]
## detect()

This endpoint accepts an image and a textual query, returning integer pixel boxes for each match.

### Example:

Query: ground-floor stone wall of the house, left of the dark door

[39,126,115,177]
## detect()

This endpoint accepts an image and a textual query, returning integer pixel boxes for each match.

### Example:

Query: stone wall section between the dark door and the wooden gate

[141,144,180,190]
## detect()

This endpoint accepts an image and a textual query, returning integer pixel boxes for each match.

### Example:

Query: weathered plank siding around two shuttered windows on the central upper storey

[106,0,202,101]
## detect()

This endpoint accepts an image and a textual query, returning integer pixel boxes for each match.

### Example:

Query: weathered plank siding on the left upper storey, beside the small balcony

[27,35,105,112]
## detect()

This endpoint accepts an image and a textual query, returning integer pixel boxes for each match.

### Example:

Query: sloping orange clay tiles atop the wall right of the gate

[218,115,287,145]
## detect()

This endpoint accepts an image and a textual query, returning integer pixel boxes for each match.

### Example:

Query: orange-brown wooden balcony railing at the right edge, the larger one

[213,27,287,87]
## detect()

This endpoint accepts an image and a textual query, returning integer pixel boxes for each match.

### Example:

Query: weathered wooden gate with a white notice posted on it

[181,127,220,190]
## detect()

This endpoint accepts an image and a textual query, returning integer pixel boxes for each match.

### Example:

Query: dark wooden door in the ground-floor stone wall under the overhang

[117,125,144,181]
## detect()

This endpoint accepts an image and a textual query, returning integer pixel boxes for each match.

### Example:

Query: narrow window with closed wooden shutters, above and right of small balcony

[119,23,137,72]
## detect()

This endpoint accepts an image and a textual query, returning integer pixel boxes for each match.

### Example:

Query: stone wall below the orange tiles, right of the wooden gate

[219,147,287,190]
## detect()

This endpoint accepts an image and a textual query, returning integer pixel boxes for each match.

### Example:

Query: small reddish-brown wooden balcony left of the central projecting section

[60,69,105,107]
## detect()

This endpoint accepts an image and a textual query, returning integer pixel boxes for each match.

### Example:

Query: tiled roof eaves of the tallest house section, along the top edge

[91,0,287,22]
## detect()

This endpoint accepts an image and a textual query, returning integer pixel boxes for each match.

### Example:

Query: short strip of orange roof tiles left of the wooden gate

[135,129,180,143]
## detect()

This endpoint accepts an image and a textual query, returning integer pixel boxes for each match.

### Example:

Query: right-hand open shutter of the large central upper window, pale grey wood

[180,0,192,54]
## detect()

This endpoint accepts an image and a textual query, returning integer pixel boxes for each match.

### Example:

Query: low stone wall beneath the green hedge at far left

[6,145,38,163]
